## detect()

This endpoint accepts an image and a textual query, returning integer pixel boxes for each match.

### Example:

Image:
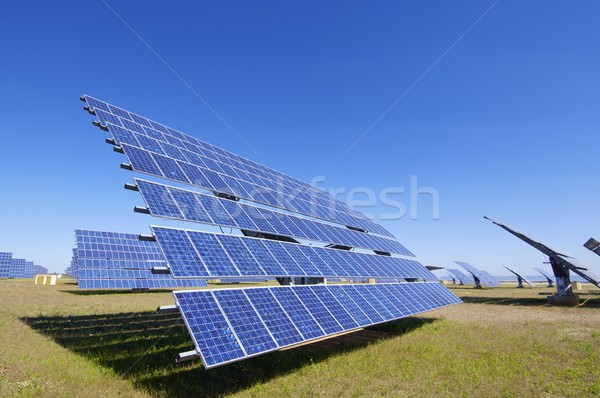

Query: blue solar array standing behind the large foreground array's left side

[73,230,206,289]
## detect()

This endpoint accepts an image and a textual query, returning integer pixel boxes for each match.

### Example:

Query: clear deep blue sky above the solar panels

[0,1,600,274]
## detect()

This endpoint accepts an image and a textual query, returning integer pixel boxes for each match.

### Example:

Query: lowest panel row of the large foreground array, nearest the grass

[173,282,460,368]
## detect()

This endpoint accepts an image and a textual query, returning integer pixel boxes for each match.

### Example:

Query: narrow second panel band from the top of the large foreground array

[135,179,413,256]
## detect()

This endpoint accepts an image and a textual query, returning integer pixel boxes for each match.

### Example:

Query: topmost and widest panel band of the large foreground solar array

[84,96,392,236]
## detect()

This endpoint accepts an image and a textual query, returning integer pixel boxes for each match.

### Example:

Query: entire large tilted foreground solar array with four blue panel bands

[78,96,460,367]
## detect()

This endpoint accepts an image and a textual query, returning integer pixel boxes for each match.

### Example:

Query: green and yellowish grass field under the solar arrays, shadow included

[0,279,600,397]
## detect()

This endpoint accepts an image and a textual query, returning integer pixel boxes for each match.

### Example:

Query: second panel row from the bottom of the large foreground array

[151,226,437,280]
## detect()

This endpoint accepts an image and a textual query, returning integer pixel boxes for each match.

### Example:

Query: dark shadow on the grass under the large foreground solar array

[20,312,435,397]
